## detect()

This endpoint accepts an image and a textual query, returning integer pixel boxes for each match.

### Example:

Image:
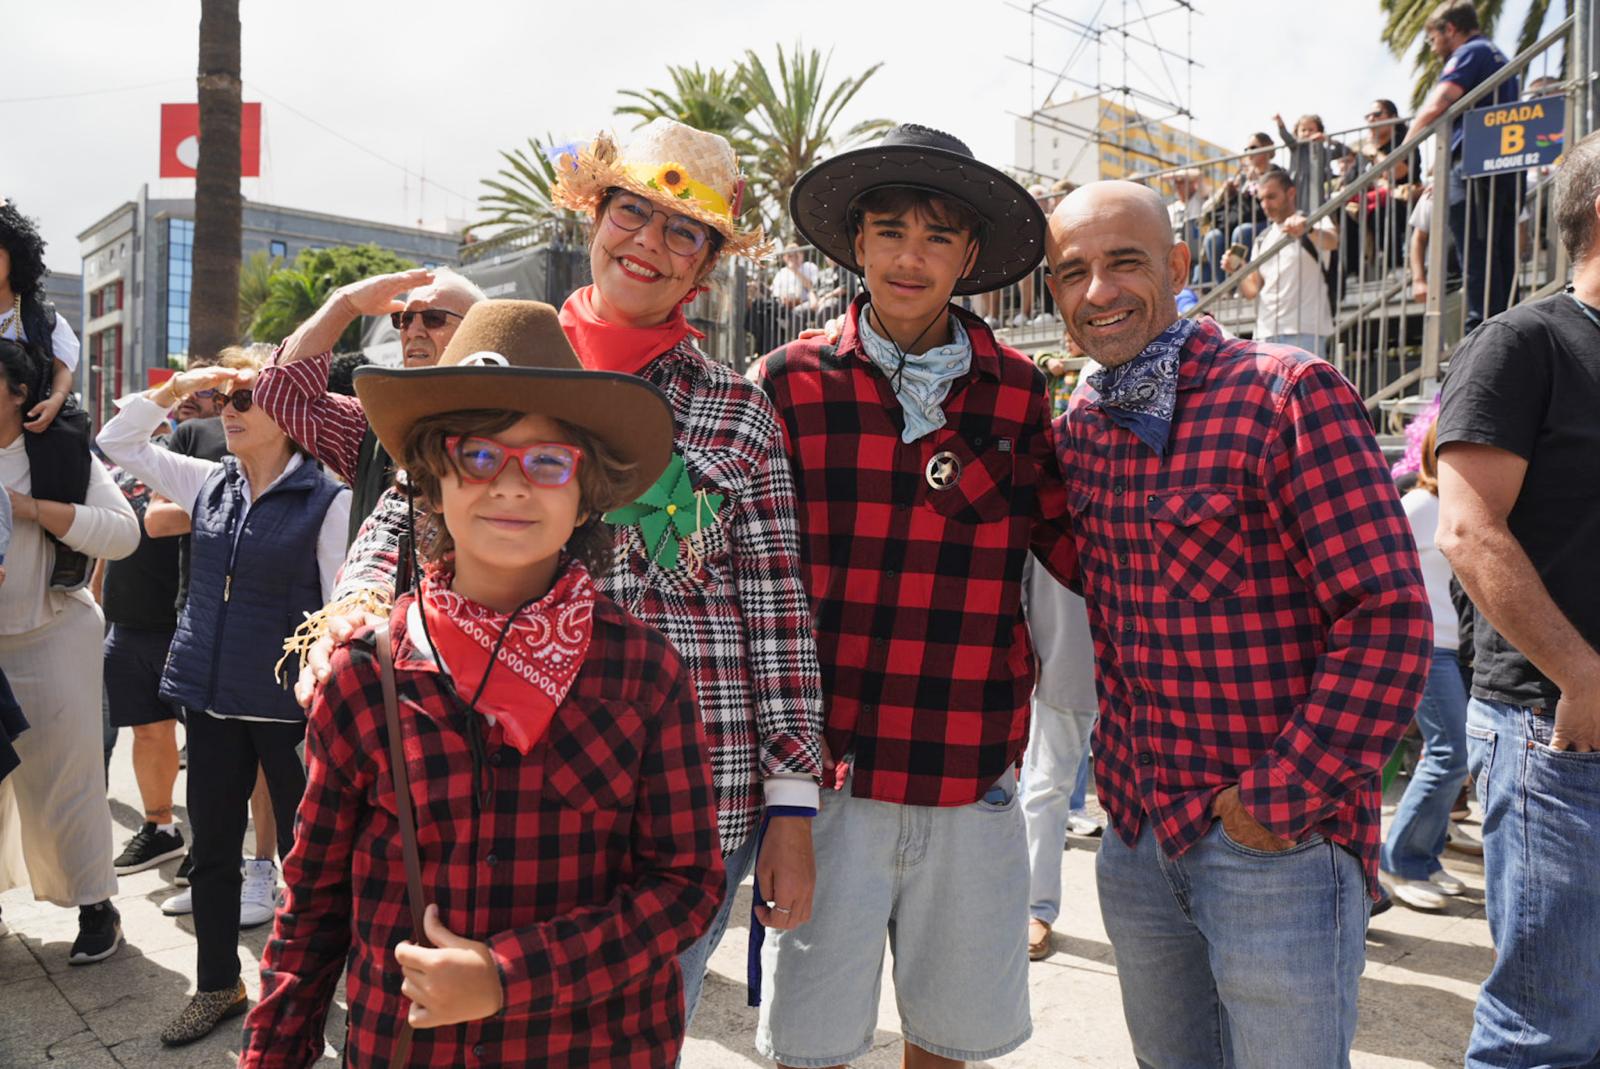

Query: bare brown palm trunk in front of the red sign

[189,0,243,360]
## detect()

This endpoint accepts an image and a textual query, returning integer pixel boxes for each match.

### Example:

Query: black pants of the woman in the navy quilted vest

[187,712,306,991]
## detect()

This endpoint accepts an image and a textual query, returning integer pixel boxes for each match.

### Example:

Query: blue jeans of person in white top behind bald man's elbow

[1379,648,1467,880]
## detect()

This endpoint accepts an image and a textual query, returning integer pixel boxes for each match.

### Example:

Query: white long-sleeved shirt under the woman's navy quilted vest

[94,394,350,602]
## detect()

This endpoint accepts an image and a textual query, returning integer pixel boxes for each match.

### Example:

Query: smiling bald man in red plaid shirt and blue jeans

[1046,182,1432,1069]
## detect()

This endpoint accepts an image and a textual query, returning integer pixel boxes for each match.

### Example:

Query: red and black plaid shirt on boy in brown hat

[240,579,725,1069]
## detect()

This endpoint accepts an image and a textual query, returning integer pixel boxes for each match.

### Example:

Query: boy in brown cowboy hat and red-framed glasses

[240,301,723,1069]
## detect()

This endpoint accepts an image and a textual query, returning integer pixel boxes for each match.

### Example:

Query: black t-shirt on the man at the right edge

[1438,293,1600,706]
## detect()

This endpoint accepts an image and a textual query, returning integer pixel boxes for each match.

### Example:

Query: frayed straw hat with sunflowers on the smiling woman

[550,118,773,259]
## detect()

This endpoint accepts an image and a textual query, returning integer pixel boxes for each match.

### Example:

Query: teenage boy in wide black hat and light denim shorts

[757,125,1072,1067]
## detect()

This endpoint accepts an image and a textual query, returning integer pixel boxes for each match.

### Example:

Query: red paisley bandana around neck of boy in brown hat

[418,560,595,754]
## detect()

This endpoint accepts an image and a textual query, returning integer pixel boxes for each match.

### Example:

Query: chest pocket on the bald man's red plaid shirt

[1146,486,1245,602]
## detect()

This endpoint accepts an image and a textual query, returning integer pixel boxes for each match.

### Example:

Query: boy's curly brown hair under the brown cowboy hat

[398,408,632,576]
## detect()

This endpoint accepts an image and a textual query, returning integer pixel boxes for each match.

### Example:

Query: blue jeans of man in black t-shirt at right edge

[1467,698,1600,1069]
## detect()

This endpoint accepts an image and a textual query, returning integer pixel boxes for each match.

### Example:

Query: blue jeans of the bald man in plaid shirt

[1096,818,1368,1069]
